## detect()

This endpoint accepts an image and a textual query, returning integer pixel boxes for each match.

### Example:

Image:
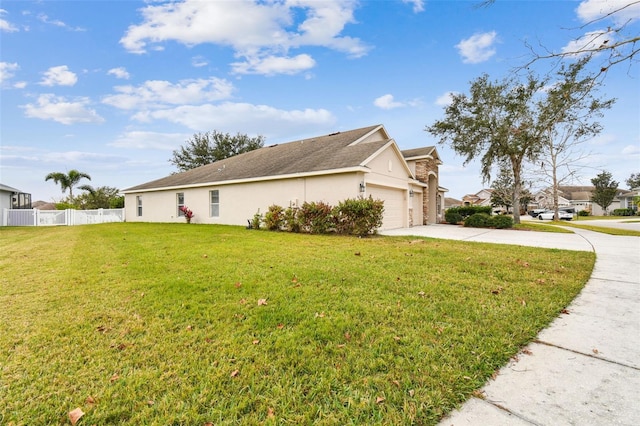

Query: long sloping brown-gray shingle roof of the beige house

[125,125,389,192]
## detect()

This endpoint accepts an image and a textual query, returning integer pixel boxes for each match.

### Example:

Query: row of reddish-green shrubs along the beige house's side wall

[251,196,384,237]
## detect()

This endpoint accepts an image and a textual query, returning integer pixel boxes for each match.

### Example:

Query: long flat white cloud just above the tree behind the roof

[134,102,335,135]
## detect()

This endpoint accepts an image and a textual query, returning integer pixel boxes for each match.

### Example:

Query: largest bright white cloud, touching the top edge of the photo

[120,0,369,74]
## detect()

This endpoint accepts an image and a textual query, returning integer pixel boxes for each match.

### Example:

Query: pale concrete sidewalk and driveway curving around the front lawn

[382,224,640,426]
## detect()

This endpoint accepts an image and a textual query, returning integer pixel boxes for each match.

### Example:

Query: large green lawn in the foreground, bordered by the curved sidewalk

[0,223,595,425]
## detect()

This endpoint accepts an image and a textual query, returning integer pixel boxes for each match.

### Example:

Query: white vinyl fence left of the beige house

[0,209,124,226]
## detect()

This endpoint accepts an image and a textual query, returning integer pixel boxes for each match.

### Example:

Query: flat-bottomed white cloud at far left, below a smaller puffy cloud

[22,94,104,124]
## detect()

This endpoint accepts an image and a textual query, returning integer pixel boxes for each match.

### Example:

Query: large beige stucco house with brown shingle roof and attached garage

[123,125,444,229]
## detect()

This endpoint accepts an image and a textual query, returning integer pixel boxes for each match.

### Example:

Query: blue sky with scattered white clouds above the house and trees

[0,0,640,201]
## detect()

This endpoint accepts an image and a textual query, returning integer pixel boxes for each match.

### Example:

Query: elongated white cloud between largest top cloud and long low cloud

[102,77,234,109]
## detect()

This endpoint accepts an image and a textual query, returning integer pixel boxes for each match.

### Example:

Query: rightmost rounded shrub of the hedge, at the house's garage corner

[333,196,384,237]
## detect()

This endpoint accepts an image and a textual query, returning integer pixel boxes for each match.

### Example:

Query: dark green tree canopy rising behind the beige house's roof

[169,130,264,172]
